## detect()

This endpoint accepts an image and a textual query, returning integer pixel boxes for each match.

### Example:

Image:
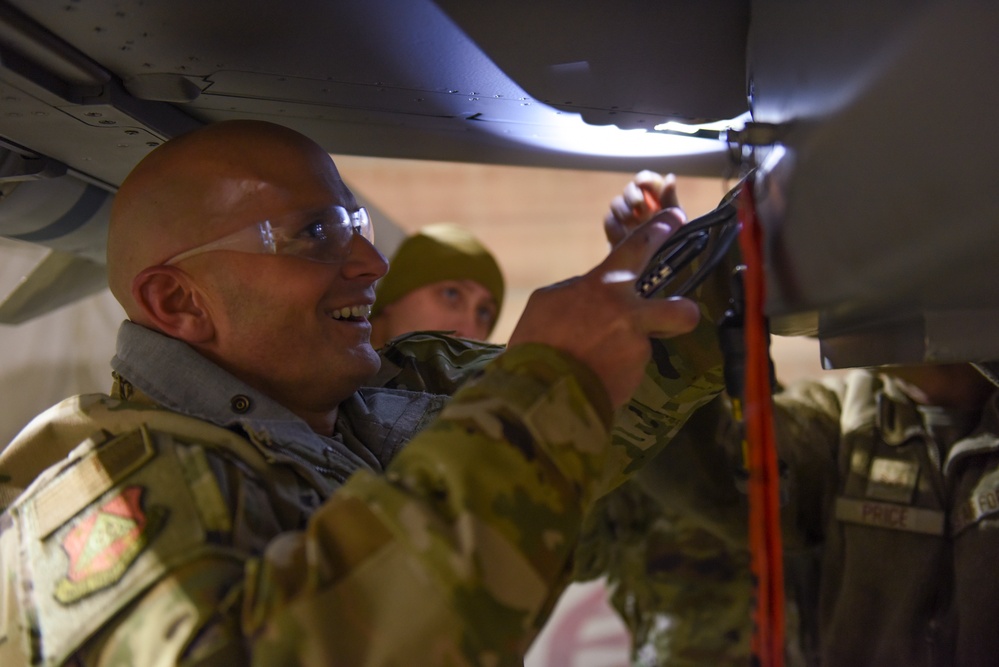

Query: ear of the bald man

[132,266,215,344]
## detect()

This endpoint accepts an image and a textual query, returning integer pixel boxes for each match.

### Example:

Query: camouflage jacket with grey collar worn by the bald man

[0,323,721,667]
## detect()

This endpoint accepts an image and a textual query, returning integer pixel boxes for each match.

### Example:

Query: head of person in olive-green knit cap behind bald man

[370,223,504,348]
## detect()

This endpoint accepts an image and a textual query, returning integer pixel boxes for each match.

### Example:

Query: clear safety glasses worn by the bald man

[163,206,375,264]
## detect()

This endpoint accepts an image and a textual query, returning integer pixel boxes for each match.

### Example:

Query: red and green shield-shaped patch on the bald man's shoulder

[55,486,166,604]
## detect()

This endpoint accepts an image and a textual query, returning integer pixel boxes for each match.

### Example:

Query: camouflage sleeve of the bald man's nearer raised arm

[243,346,611,665]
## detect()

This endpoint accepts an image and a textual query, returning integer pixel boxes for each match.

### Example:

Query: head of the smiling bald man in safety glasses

[108,119,388,435]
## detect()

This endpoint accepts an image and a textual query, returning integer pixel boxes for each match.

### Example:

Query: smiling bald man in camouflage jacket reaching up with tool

[0,121,720,666]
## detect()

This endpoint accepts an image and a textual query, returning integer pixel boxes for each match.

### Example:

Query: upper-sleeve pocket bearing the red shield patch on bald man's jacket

[12,428,223,664]
